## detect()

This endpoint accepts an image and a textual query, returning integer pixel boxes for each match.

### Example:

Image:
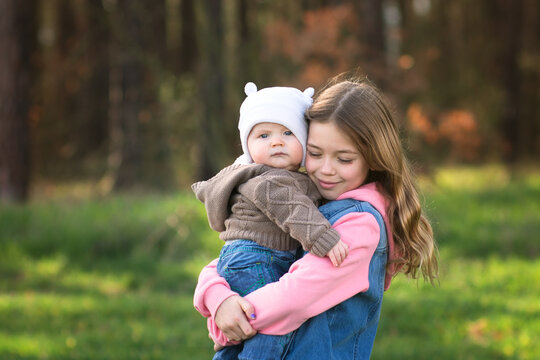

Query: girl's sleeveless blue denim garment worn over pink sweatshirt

[282,199,388,360]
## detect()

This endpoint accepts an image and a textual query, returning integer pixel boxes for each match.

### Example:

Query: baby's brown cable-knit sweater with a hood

[191,164,339,256]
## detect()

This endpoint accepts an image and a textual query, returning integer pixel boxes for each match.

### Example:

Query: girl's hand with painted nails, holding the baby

[214,295,257,341]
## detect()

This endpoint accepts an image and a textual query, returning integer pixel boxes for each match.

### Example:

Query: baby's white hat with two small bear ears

[238,82,315,166]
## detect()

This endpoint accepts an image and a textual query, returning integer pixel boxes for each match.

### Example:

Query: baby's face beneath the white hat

[247,123,303,171]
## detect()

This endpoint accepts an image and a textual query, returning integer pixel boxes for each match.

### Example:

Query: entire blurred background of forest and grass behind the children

[0,0,540,360]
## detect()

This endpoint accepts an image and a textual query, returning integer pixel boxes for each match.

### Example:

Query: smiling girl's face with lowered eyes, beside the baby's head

[306,122,369,200]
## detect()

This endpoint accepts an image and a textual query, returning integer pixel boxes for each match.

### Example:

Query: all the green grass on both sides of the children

[0,166,540,360]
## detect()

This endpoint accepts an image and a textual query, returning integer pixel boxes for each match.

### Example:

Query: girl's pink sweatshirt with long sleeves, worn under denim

[194,183,396,345]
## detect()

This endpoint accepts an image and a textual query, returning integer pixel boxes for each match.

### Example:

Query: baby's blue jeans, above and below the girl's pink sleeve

[214,240,302,360]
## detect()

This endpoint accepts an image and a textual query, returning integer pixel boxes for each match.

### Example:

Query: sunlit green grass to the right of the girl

[373,166,540,359]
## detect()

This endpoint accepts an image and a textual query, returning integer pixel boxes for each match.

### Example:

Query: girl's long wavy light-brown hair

[306,79,438,282]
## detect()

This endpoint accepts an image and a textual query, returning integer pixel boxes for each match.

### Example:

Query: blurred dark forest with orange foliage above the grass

[0,0,540,202]
